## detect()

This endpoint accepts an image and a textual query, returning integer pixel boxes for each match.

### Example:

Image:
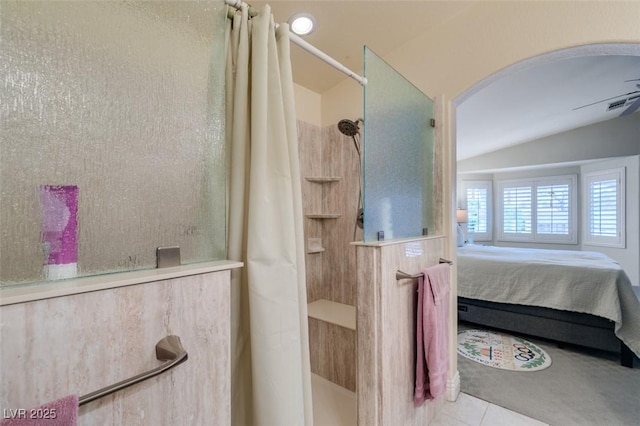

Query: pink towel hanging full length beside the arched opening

[413,263,450,407]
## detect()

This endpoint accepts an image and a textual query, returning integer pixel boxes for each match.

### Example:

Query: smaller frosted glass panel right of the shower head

[363,47,434,242]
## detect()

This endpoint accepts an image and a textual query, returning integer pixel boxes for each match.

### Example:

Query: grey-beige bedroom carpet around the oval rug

[458,323,640,426]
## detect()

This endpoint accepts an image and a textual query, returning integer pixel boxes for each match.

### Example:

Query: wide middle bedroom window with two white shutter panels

[498,175,578,244]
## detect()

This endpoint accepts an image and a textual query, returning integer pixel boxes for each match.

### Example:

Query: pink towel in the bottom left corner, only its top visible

[0,395,78,426]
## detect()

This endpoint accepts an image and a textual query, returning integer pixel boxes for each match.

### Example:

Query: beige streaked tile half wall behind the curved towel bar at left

[0,271,231,425]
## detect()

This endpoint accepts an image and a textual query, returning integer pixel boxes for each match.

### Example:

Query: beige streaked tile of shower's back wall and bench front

[298,121,362,391]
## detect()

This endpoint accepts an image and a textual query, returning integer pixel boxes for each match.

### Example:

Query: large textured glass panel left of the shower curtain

[0,1,226,286]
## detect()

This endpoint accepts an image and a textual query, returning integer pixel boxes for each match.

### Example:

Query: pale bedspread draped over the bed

[458,245,640,357]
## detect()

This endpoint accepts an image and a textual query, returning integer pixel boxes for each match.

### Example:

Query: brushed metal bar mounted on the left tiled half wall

[79,336,189,405]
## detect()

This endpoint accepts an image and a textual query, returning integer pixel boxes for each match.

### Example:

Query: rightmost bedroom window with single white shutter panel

[584,168,625,248]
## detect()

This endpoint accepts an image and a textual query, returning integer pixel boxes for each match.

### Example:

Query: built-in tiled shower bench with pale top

[307,299,357,392]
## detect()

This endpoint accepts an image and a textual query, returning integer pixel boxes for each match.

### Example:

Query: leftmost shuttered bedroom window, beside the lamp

[462,180,493,241]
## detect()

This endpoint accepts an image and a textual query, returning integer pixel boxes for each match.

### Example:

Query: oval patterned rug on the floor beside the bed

[458,330,551,371]
